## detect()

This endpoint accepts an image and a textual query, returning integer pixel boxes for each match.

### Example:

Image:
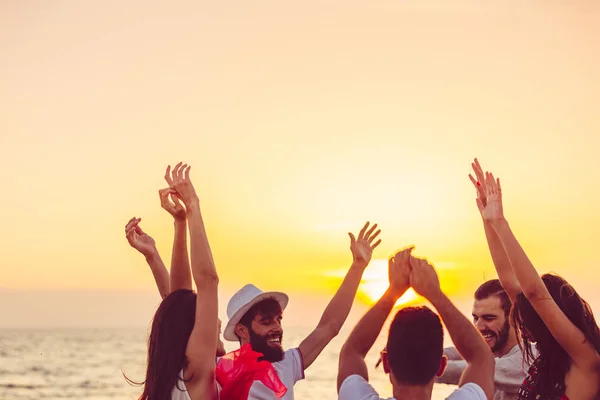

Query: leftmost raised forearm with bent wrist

[125,217,170,299]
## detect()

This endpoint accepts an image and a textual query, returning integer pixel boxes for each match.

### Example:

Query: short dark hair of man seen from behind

[387,306,444,385]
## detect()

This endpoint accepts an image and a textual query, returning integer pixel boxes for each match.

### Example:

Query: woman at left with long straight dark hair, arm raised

[129,163,219,400]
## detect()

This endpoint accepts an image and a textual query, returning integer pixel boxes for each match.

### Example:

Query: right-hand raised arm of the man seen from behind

[410,257,494,399]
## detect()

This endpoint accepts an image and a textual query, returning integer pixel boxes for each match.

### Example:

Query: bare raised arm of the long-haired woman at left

[172,162,219,398]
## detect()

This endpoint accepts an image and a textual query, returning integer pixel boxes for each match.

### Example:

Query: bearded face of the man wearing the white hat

[235,298,283,362]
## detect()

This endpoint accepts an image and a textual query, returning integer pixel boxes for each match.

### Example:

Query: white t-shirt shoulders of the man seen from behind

[338,375,487,400]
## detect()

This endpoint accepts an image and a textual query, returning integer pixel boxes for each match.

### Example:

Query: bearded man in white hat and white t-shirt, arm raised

[223,222,381,400]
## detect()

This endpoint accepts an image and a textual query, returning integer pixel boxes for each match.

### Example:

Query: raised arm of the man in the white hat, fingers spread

[299,222,381,369]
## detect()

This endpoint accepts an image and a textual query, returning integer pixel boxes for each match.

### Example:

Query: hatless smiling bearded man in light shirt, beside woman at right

[437,279,535,400]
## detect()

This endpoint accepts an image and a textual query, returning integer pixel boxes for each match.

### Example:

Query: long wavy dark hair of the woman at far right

[512,274,600,399]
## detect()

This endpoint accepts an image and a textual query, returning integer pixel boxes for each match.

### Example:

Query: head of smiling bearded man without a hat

[473,279,517,357]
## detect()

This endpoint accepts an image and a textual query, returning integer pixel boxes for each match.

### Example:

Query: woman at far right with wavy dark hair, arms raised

[469,159,600,400]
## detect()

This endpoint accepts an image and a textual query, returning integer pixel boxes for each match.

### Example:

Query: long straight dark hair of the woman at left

[125,289,196,400]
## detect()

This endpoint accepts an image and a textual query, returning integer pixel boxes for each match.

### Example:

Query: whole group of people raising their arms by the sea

[125,160,600,400]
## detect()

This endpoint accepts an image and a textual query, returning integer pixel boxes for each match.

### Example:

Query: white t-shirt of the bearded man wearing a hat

[216,349,304,400]
